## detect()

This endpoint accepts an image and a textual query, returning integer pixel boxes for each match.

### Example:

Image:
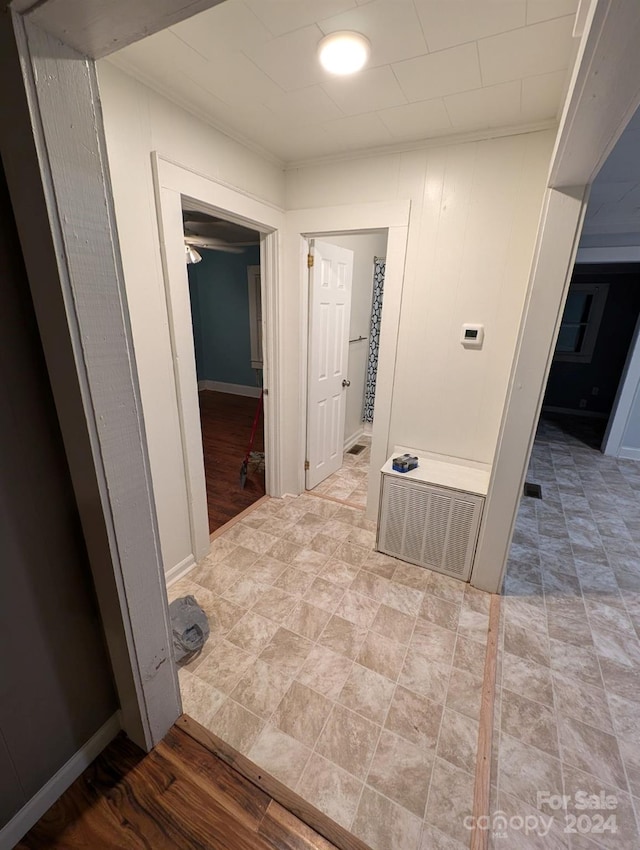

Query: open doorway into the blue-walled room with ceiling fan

[183,206,265,533]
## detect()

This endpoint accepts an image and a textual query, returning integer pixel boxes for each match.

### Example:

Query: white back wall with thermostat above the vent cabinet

[286,131,554,463]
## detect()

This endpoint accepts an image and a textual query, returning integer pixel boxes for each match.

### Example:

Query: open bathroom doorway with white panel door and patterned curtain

[305,230,388,508]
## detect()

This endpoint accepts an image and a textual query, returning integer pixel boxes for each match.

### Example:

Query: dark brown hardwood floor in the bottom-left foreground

[16,726,335,850]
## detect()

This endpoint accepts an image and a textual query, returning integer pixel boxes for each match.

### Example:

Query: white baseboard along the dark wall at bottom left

[0,711,122,850]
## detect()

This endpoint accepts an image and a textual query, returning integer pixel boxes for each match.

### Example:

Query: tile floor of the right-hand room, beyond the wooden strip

[492,420,640,850]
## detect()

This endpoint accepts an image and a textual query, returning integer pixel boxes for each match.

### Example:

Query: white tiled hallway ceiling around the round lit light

[109,0,578,162]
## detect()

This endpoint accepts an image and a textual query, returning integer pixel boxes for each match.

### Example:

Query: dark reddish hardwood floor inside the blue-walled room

[198,390,265,532]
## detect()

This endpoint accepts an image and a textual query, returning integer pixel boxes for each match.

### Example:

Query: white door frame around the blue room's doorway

[151,151,284,560]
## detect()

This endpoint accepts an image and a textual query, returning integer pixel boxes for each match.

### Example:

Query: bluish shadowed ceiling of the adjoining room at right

[580,110,640,248]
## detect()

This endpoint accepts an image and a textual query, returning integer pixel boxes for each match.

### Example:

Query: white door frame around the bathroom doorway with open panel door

[285,200,411,519]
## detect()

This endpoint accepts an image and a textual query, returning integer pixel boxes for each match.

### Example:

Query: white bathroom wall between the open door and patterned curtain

[326,231,387,445]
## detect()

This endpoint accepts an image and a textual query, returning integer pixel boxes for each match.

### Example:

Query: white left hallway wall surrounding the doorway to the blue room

[98,61,284,570]
